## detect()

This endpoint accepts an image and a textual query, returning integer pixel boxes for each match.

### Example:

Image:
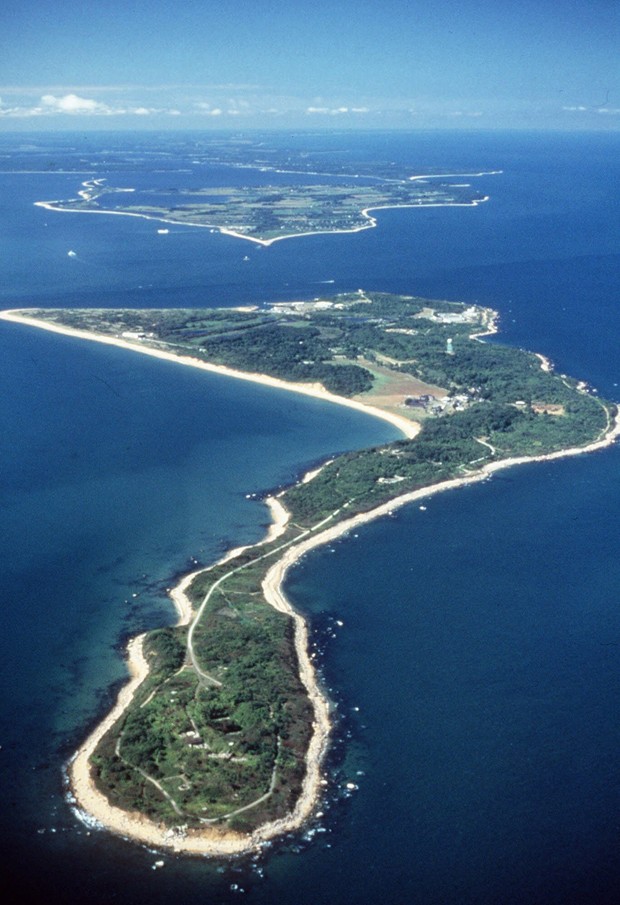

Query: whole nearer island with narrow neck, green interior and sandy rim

[0,289,619,856]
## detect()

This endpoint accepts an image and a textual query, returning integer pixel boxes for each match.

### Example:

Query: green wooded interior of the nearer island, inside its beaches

[36,291,613,830]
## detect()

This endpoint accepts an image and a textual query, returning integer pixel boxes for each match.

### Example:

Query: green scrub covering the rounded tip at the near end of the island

[93,598,312,829]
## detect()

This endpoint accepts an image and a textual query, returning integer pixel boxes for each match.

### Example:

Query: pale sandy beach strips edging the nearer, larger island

[0,309,620,857]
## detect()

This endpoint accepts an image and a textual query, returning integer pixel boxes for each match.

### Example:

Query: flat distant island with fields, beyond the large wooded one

[36,173,490,246]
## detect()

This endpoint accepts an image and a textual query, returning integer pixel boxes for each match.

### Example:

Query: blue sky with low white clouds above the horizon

[0,0,620,132]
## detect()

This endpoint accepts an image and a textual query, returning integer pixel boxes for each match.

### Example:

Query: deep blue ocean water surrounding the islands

[0,133,620,905]
